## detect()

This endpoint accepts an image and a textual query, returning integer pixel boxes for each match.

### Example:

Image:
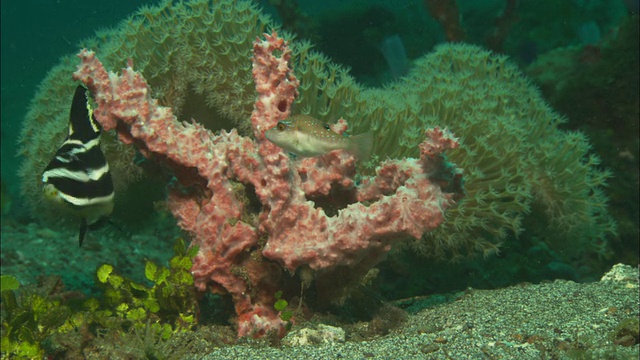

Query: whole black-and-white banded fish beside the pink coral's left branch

[42,85,114,246]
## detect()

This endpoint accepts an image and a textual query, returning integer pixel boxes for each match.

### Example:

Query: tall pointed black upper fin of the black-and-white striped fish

[67,85,102,144]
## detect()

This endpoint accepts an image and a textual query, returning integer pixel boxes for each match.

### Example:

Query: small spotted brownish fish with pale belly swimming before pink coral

[265,115,373,160]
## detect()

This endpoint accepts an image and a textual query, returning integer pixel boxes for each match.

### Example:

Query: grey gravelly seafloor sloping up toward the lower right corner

[199,265,639,360]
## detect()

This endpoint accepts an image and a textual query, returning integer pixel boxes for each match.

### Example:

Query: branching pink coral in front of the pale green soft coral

[73,33,462,337]
